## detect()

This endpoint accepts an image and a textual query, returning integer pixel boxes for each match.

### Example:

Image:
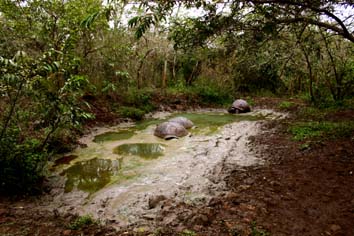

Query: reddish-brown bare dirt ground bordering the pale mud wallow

[0,99,354,236]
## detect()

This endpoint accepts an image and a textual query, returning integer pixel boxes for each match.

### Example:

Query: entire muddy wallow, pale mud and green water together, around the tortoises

[40,109,286,229]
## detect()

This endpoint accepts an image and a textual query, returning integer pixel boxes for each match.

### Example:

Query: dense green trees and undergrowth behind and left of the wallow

[0,0,354,192]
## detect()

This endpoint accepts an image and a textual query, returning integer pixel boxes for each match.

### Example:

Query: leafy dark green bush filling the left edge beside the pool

[0,0,98,193]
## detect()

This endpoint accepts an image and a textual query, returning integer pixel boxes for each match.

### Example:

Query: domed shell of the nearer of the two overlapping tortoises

[154,121,188,139]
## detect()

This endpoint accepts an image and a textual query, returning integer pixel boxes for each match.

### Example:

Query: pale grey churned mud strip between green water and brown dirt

[40,110,286,229]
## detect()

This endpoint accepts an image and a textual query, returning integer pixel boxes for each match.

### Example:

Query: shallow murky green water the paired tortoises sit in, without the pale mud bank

[55,112,265,193]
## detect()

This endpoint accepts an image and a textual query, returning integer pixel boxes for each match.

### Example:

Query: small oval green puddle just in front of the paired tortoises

[113,143,165,159]
